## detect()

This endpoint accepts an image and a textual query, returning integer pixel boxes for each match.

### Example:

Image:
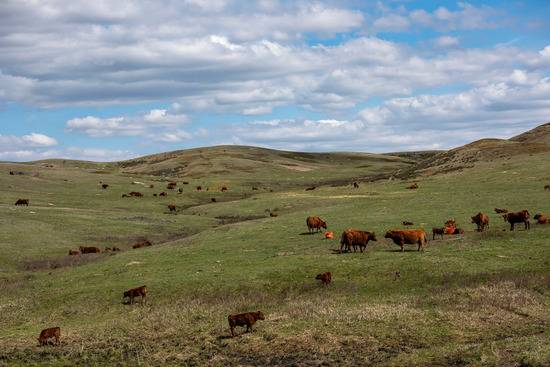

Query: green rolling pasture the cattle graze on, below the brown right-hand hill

[0,147,550,366]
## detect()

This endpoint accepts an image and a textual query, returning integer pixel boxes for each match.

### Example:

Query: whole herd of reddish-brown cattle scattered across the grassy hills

[10,172,550,345]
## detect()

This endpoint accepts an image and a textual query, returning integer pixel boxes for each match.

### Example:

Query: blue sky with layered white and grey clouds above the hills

[0,0,550,161]
